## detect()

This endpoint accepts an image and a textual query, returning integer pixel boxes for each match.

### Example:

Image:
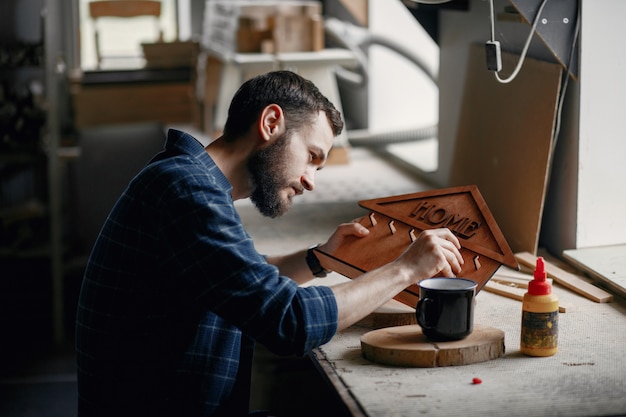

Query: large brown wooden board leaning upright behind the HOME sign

[450,45,561,253]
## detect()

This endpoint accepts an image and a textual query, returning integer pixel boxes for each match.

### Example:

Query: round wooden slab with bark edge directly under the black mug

[361,325,504,368]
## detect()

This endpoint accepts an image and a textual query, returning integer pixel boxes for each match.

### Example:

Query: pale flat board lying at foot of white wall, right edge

[563,245,626,297]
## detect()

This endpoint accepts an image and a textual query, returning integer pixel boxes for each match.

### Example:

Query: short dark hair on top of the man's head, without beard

[224,71,343,140]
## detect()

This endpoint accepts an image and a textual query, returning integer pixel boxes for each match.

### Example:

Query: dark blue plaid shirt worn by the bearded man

[76,130,337,417]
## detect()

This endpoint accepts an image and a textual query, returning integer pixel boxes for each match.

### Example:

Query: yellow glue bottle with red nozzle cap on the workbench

[520,257,559,356]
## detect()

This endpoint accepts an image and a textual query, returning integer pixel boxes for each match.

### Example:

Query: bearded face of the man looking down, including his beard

[248,112,334,218]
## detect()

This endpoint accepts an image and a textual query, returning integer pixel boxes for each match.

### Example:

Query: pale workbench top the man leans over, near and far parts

[237,148,626,417]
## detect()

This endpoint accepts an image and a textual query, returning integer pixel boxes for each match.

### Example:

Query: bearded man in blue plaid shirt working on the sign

[76,71,463,417]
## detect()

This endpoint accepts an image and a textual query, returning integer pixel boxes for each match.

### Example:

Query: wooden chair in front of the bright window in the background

[89,0,163,69]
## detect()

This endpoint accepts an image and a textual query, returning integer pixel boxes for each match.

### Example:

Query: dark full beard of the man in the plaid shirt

[248,133,292,218]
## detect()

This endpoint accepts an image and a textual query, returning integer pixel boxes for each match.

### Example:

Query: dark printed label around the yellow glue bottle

[521,311,559,349]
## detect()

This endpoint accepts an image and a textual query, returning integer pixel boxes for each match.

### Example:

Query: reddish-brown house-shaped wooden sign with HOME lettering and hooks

[316,185,519,307]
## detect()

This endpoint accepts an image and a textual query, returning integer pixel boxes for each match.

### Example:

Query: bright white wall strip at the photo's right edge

[576,0,626,248]
